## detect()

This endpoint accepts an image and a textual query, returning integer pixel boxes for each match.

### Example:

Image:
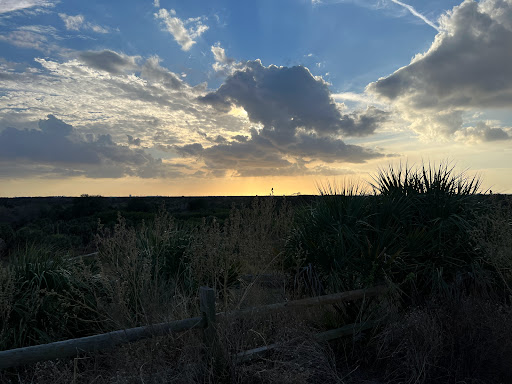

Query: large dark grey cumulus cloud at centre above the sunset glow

[174,60,387,176]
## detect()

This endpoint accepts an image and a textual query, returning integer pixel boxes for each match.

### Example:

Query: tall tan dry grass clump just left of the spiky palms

[186,197,293,308]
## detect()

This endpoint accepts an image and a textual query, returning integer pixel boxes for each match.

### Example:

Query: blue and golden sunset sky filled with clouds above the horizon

[0,0,512,197]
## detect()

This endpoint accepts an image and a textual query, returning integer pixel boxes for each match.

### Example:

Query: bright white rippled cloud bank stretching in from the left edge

[0,52,249,170]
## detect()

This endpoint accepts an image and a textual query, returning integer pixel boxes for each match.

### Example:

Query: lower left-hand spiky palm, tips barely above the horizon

[287,184,400,290]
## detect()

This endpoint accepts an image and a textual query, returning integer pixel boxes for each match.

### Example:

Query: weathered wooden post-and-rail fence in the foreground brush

[0,286,386,369]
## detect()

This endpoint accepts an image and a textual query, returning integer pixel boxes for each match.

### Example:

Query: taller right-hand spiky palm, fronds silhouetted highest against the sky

[371,162,484,293]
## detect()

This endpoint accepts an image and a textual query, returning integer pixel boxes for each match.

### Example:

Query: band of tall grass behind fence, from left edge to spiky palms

[0,198,292,349]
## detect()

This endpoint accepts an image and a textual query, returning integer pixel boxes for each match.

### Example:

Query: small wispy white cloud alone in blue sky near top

[154,8,208,51]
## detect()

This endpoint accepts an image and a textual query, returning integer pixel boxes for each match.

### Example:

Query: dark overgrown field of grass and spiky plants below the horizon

[0,165,512,383]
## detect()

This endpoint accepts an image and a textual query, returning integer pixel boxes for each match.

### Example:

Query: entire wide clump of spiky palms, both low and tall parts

[288,162,492,306]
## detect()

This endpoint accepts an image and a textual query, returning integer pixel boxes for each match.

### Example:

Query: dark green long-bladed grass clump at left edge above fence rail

[0,245,104,349]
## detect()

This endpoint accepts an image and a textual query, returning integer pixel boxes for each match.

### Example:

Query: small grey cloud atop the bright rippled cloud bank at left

[78,50,139,74]
